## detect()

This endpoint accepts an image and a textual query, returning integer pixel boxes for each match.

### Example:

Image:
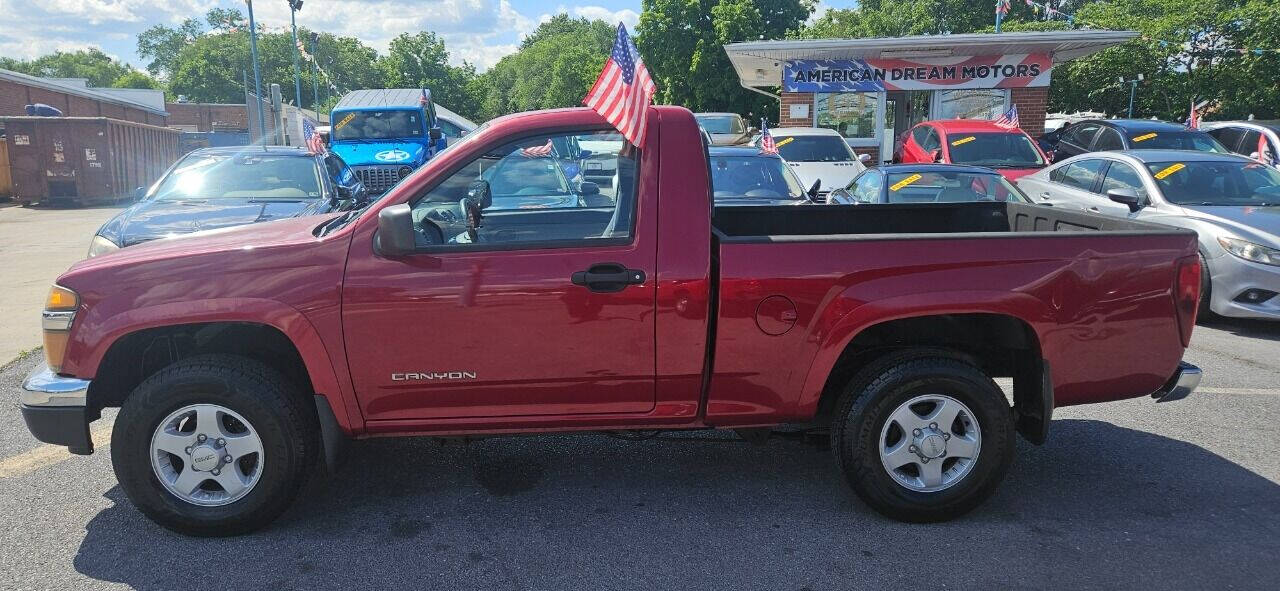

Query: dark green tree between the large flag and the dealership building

[636,0,817,116]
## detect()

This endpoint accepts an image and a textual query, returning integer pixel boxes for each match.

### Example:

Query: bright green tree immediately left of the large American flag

[481,14,617,119]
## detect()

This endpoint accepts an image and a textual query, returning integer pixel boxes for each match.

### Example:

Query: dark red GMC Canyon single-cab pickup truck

[22,106,1201,536]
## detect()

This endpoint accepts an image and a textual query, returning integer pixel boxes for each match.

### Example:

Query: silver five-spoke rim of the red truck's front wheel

[151,404,262,507]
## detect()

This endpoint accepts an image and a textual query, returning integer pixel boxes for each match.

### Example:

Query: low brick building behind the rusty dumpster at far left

[0,69,168,127]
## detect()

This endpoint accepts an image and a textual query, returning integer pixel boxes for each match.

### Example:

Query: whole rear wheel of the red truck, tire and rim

[831,351,1014,523]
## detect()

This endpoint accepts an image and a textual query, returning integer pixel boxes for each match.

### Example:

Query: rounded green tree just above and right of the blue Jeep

[378,31,483,118]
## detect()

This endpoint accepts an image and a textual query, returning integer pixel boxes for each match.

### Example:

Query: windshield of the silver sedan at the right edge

[1147,160,1280,206]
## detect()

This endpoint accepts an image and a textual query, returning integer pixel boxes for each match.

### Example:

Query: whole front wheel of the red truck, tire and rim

[111,356,319,536]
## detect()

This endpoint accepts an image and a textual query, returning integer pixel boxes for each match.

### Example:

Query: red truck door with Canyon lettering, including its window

[342,130,657,421]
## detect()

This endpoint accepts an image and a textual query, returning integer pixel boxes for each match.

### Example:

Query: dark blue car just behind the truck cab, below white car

[709,146,813,206]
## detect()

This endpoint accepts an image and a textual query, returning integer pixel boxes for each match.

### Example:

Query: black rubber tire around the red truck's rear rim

[831,349,1014,523]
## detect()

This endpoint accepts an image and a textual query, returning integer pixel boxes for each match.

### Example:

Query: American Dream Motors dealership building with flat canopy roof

[724,29,1138,161]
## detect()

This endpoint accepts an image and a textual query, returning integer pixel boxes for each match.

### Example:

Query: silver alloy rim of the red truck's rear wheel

[879,394,982,493]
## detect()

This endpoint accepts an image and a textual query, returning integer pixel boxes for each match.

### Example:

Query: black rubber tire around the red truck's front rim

[111,354,320,536]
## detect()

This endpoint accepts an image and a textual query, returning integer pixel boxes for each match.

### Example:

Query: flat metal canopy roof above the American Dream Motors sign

[724,29,1138,87]
